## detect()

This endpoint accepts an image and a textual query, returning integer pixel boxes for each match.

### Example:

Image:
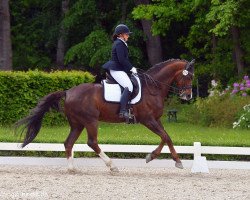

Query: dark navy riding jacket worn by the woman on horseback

[102,39,133,73]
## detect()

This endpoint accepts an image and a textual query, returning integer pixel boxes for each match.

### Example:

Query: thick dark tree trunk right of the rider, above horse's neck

[135,0,162,65]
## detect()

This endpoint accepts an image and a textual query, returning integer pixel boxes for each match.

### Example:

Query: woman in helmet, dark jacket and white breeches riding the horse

[102,24,137,119]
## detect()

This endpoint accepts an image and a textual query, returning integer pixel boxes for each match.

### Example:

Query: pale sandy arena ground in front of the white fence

[0,165,250,200]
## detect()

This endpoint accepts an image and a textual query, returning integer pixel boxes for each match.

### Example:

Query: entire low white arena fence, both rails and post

[0,142,250,172]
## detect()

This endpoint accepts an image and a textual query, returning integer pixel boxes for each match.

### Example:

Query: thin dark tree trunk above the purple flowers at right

[232,26,244,75]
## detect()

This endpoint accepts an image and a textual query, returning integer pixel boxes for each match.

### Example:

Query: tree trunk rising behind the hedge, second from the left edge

[56,0,69,67]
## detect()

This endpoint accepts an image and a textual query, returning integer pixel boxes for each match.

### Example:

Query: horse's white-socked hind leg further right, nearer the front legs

[86,122,119,172]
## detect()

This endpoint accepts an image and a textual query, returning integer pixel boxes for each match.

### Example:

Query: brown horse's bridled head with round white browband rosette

[175,59,195,101]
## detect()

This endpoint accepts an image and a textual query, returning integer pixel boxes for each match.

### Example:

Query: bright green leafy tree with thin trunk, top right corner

[207,0,250,75]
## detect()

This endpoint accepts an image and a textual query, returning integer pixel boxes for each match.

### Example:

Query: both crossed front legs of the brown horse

[143,119,183,169]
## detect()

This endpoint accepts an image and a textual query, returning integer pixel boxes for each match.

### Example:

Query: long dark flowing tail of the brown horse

[15,91,66,147]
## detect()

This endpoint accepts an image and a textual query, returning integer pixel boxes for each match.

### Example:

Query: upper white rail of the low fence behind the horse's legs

[0,142,250,157]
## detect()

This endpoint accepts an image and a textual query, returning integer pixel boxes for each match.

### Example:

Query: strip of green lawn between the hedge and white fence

[0,122,250,147]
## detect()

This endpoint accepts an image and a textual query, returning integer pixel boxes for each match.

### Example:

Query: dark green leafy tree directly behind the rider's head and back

[64,0,144,70]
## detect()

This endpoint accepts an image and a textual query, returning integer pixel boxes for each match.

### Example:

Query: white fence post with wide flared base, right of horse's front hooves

[191,142,209,173]
